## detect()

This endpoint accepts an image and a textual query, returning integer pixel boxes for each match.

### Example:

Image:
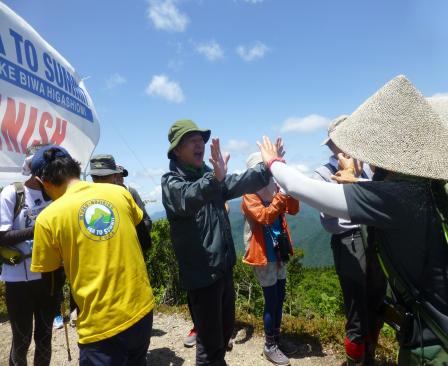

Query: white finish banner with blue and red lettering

[0,2,100,179]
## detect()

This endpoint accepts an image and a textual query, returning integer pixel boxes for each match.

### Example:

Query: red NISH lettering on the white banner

[0,94,68,154]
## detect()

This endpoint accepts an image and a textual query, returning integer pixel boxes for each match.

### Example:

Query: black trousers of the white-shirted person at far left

[6,279,58,366]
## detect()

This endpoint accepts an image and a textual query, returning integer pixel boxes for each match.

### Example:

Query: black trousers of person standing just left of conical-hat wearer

[331,230,386,343]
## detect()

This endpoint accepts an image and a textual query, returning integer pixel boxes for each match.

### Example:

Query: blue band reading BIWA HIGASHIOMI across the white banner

[0,56,93,122]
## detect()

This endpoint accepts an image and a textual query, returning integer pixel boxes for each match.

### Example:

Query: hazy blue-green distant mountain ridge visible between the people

[151,199,333,267]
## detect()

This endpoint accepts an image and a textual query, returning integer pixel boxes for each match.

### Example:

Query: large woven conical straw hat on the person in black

[330,75,448,179]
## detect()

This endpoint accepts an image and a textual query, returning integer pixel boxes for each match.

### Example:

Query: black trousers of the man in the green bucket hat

[187,271,235,366]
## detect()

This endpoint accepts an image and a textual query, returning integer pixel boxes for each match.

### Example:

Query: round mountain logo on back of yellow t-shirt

[78,200,120,241]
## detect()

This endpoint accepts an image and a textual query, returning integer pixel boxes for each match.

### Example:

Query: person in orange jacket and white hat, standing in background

[241,153,299,365]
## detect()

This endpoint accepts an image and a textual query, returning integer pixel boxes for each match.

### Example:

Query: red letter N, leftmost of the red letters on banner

[2,98,26,153]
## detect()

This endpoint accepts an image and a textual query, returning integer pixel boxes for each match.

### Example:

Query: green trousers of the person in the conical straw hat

[398,346,448,366]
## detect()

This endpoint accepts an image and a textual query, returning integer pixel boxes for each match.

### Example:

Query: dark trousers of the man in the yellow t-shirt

[79,311,153,366]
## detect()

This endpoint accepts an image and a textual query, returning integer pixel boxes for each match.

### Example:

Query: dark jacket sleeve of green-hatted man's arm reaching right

[223,163,272,201]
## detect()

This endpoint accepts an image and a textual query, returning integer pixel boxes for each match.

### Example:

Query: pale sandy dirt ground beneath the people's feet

[0,313,342,366]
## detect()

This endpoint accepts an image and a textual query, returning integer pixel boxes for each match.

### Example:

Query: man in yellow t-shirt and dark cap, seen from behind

[31,146,154,366]
